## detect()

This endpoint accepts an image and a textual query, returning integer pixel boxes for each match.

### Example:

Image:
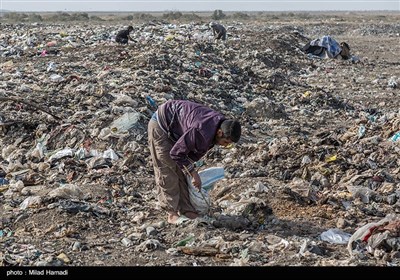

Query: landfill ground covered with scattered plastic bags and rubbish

[0,13,400,267]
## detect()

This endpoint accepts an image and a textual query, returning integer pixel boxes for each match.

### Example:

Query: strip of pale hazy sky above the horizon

[0,0,400,12]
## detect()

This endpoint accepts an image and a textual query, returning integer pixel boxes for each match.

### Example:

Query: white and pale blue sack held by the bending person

[187,167,225,215]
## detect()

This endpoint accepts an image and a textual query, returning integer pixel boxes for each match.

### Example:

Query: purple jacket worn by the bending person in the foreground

[157,100,225,171]
